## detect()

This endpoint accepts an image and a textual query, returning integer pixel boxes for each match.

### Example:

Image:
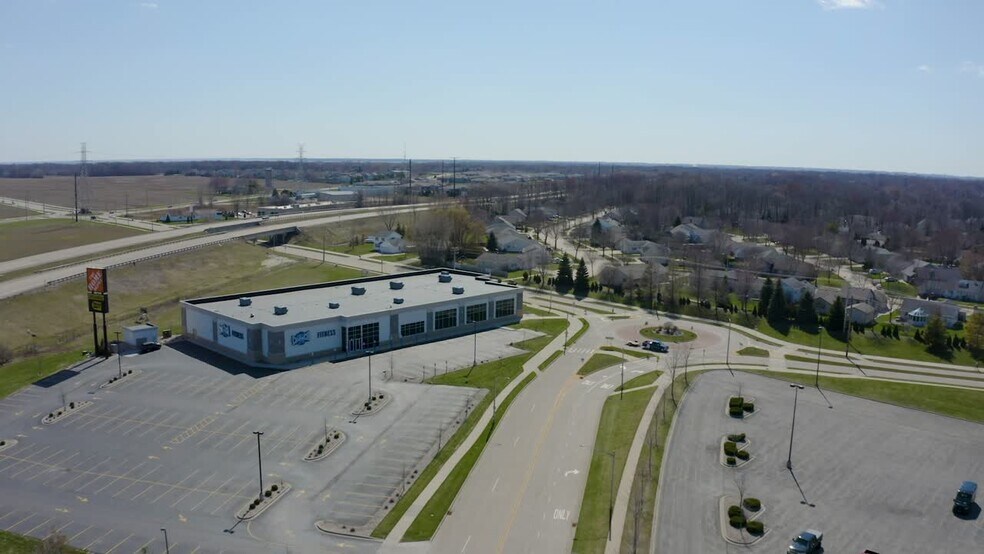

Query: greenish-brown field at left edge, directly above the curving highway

[0,219,146,262]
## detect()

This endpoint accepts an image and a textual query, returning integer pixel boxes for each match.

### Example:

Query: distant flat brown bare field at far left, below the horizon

[0,175,208,212]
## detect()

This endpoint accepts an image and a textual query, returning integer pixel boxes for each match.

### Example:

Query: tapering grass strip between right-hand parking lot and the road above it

[748,371,984,423]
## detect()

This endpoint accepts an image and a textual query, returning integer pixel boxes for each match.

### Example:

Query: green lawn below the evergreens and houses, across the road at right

[756,318,975,366]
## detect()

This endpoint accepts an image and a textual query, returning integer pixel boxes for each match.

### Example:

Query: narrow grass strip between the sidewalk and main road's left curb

[402,373,536,542]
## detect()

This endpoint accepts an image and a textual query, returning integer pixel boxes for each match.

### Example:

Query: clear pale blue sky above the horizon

[0,0,984,176]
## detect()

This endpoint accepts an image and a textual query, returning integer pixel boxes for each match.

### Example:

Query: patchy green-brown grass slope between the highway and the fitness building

[0,242,361,395]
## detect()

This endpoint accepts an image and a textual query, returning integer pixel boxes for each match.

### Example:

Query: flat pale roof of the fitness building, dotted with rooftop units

[185,269,516,327]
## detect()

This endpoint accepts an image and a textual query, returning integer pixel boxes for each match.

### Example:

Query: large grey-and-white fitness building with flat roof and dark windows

[181,269,523,366]
